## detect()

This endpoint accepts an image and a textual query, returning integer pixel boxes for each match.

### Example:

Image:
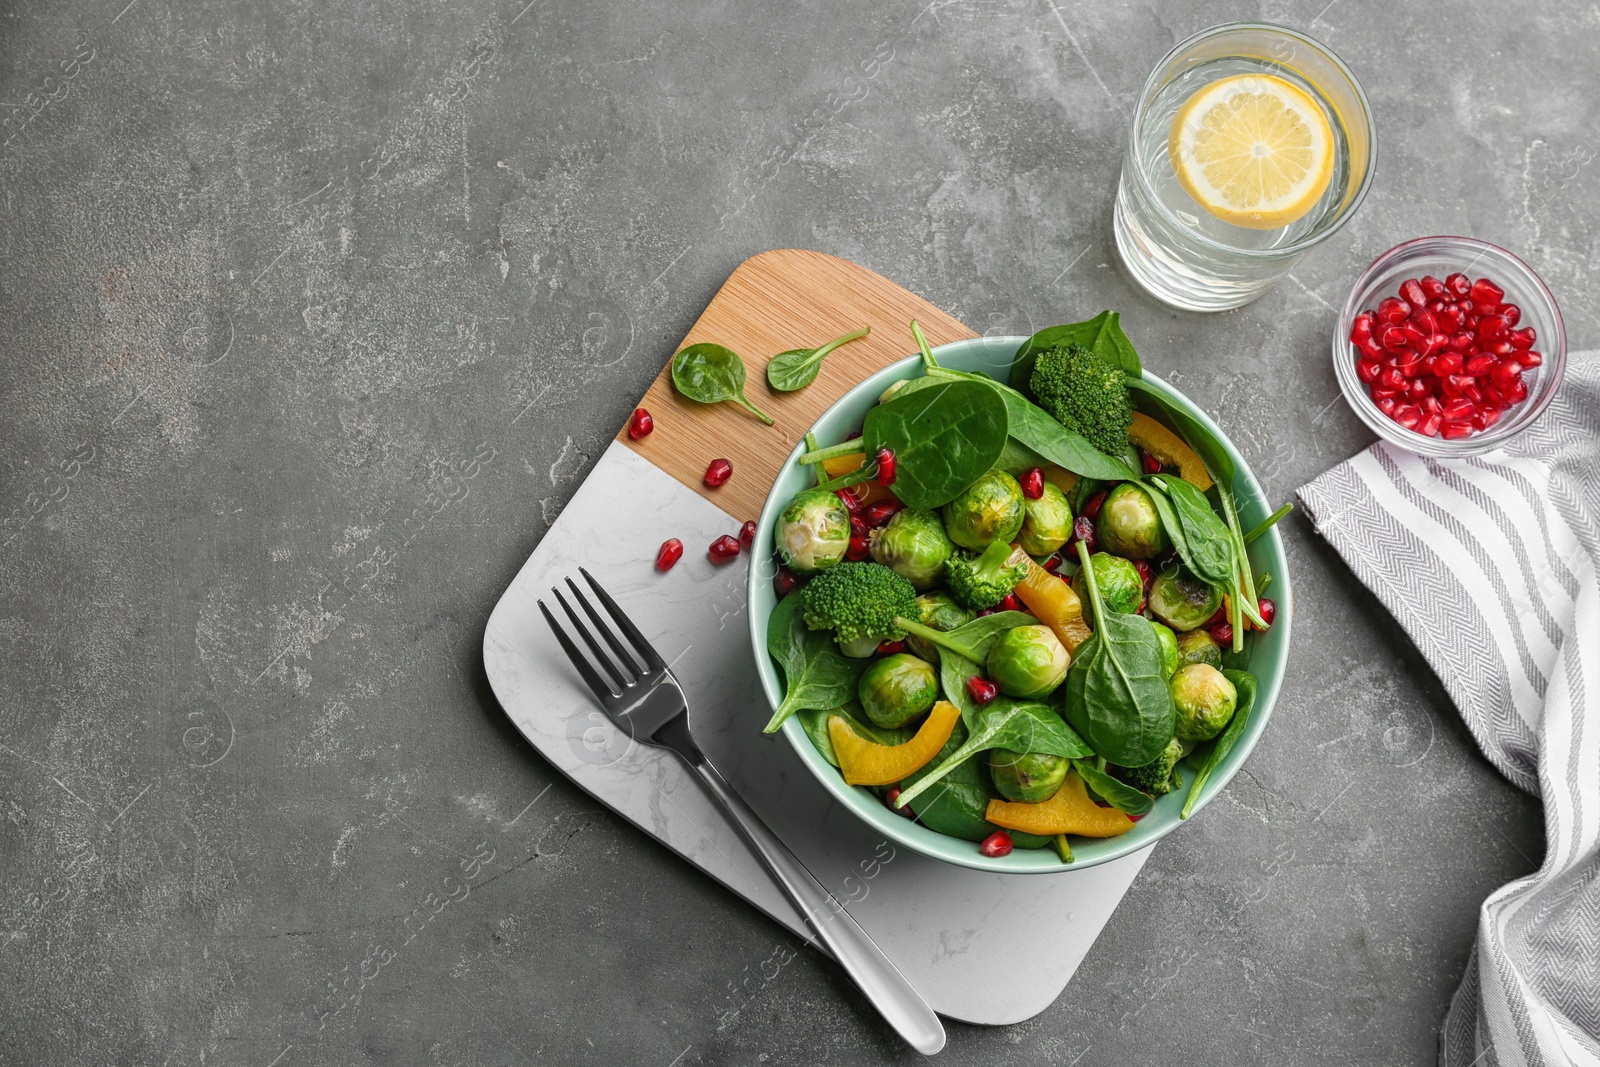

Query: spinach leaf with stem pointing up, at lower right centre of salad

[1066,541,1174,766]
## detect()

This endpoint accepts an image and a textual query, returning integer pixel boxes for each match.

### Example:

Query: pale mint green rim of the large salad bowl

[746,336,1294,875]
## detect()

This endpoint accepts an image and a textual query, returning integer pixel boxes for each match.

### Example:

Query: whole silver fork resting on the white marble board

[539,568,944,1056]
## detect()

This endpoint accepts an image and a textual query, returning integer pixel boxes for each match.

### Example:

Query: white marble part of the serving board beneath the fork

[483,442,1149,1025]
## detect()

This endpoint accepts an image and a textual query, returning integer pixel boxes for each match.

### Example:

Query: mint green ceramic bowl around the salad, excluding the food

[749,338,1294,875]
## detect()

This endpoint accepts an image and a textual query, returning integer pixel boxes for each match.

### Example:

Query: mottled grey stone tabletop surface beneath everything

[0,0,1580,1067]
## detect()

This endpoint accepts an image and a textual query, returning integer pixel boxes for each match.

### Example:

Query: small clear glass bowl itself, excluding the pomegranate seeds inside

[1333,237,1566,456]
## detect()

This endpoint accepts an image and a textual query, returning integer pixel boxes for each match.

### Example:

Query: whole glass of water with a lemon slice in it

[1114,22,1378,312]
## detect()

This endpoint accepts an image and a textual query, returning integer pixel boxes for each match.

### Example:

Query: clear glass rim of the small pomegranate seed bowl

[1333,234,1566,459]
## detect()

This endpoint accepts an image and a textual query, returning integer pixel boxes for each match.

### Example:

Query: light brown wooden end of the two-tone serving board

[616,248,978,522]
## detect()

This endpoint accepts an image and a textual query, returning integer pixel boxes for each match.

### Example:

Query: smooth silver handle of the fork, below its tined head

[680,752,944,1056]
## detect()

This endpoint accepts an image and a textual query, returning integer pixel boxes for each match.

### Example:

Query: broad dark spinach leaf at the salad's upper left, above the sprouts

[861,381,1006,509]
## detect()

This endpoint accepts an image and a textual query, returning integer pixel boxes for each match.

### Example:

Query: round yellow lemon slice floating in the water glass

[1166,74,1333,230]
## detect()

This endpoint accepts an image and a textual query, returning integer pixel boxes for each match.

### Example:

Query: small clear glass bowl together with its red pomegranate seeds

[1333,237,1566,456]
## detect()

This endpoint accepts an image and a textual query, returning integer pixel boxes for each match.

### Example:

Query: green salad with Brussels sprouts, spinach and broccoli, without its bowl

[766,312,1290,862]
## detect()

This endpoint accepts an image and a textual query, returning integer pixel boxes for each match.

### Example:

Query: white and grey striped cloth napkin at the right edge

[1299,352,1600,1067]
